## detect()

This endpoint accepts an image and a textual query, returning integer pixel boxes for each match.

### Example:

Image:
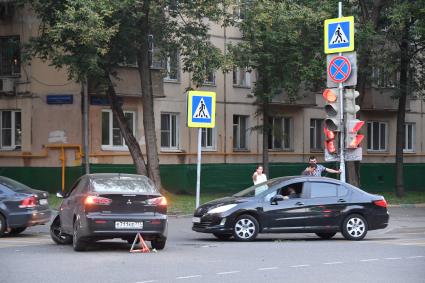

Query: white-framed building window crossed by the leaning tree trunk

[102,110,136,149]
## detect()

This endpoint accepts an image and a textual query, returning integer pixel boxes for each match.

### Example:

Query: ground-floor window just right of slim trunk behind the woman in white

[268,117,291,150]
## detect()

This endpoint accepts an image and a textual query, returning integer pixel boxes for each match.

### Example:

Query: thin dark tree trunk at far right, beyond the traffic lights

[395,23,409,198]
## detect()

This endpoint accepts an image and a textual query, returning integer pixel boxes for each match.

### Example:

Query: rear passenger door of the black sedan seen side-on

[305,181,348,231]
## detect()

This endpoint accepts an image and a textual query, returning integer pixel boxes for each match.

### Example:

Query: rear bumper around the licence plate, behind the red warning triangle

[80,213,168,240]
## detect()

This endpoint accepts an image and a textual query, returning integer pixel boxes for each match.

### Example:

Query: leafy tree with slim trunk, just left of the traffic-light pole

[230,0,329,174]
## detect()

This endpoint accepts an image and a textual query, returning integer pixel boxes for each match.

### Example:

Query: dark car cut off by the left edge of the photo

[0,176,51,237]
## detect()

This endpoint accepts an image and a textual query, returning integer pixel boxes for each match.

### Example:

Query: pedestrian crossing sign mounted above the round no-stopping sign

[324,16,354,54]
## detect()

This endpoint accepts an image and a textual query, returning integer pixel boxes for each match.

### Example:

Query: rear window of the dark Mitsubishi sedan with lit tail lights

[92,176,159,194]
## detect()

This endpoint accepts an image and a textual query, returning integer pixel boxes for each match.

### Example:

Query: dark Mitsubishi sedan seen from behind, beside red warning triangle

[50,174,168,251]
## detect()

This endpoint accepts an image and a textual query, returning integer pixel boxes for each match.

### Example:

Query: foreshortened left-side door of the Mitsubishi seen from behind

[60,179,86,233]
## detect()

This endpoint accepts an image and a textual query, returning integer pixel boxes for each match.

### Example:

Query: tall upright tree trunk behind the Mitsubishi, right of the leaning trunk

[137,0,163,190]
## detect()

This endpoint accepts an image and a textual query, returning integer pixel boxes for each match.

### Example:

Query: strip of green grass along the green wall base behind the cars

[49,192,425,215]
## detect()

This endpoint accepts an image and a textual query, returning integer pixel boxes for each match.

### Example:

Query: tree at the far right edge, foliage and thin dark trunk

[384,0,425,197]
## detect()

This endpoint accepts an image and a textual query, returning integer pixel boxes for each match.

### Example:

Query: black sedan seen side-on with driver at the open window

[192,176,389,241]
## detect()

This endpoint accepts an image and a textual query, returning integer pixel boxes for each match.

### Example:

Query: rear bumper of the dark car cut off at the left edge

[7,209,52,228]
